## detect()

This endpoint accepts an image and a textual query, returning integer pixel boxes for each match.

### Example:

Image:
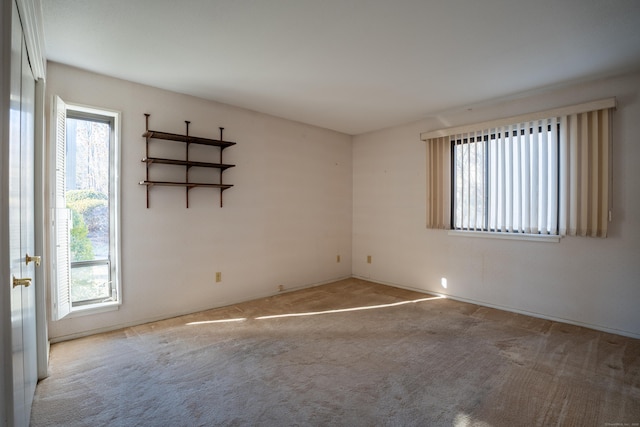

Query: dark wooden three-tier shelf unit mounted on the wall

[140,114,236,208]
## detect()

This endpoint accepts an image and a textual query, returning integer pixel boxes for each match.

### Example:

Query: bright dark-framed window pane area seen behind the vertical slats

[451,119,559,235]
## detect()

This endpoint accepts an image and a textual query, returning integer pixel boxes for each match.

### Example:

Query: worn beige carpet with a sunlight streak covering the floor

[31,279,640,427]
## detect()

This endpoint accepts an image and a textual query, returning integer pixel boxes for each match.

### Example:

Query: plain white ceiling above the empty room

[41,0,640,134]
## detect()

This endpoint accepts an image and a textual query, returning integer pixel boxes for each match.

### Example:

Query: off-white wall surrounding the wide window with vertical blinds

[353,74,640,337]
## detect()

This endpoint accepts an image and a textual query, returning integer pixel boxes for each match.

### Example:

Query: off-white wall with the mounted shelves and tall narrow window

[47,63,352,340]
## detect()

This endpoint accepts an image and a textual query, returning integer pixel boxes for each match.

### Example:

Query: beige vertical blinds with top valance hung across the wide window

[421,99,615,237]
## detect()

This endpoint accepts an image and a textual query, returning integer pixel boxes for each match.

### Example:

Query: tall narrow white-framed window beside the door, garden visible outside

[52,97,121,319]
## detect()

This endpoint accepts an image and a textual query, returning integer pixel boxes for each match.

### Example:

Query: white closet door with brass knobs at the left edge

[3,3,37,426]
